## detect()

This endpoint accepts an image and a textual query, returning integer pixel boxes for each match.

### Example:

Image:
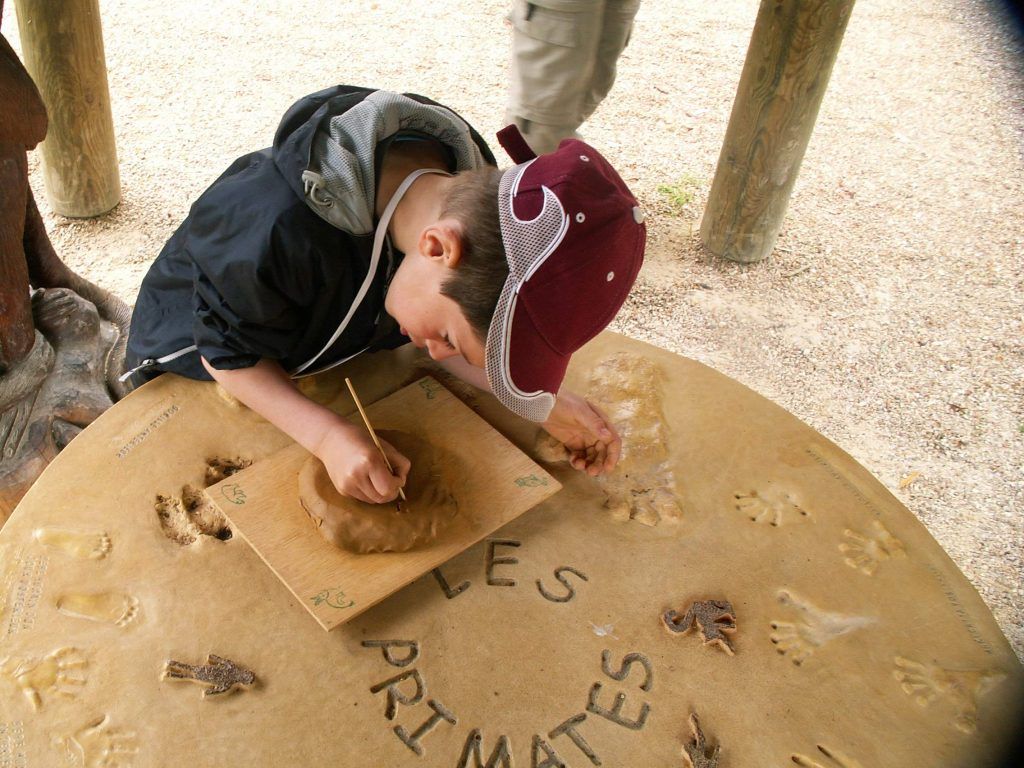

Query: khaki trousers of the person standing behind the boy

[505,0,640,154]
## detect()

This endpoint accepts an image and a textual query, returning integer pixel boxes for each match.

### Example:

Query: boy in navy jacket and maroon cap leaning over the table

[124,86,645,503]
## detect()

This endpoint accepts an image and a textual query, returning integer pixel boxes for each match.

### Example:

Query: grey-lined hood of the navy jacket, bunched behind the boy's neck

[273,86,494,236]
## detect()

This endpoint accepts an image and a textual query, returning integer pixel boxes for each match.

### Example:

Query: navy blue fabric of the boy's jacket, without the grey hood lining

[126,86,495,384]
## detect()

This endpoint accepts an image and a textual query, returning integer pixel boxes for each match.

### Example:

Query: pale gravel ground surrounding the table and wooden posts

[3,0,1024,657]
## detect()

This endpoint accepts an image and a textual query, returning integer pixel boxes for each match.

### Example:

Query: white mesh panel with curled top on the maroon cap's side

[484,160,569,422]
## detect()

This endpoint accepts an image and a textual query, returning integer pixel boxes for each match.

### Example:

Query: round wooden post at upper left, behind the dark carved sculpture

[14,0,121,218]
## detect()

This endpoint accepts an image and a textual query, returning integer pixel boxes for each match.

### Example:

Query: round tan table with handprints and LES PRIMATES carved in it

[0,334,1024,768]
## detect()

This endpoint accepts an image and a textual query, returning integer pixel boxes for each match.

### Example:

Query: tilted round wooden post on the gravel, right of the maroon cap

[700,0,854,263]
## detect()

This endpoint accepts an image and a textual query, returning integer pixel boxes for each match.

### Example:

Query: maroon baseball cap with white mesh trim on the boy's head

[484,125,647,422]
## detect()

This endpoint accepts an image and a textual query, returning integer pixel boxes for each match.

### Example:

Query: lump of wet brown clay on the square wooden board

[299,430,458,554]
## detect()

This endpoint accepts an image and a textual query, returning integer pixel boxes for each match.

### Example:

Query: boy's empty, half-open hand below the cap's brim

[542,390,623,477]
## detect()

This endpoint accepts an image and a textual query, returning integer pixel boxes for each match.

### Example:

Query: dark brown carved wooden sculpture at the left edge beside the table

[0,7,131,524]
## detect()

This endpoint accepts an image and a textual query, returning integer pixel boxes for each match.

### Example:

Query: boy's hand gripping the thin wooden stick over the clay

[315,424,411,504]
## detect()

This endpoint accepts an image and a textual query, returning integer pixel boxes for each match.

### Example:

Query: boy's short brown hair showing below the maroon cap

[441,166,509,342]
